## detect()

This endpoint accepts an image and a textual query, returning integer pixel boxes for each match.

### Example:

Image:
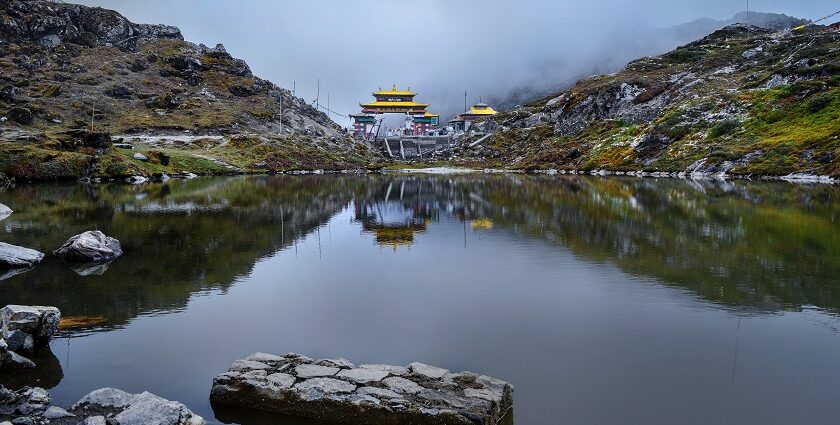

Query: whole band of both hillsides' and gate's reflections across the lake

[0,175,840,334]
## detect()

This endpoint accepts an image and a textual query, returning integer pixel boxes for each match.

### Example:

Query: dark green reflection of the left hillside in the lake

[0,176,352,328]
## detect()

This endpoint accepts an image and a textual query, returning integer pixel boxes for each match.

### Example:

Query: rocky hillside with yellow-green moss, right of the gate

[480,25,840,176]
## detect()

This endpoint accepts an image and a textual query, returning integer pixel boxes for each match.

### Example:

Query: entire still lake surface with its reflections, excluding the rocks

[0,175,840,425]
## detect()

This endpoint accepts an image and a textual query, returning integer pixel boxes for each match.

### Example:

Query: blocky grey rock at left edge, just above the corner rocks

[0,305,61,370]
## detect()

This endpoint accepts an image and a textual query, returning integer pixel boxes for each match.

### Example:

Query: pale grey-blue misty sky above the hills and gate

[81,0,838,125]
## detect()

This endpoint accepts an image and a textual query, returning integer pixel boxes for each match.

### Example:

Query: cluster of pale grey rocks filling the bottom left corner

[0,386,206,425]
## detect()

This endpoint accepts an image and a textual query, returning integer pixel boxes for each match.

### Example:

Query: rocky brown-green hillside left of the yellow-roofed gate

[0,0,376,179]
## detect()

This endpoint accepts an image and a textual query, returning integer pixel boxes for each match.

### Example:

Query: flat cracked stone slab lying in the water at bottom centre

[210,353,513,425]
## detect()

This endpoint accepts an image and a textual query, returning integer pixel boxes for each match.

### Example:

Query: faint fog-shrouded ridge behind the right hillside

[485,12,809,114]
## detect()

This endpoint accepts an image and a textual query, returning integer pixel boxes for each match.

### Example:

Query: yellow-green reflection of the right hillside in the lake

[356,175,840,311]
